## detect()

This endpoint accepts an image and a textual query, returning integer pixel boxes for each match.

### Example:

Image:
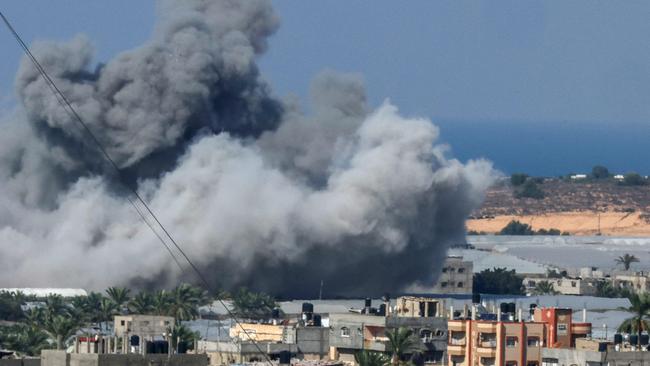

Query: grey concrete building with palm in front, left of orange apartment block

[329,297,447,363]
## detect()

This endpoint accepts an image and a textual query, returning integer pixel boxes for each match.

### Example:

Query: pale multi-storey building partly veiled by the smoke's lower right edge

[432,256,474,294]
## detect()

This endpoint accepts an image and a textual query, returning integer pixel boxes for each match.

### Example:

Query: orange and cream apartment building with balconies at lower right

[447,308,591,366]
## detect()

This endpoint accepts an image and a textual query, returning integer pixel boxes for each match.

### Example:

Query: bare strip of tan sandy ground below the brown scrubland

[467,212,650,236]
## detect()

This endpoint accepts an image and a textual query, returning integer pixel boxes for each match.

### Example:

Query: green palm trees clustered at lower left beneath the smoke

[0,284,276,356]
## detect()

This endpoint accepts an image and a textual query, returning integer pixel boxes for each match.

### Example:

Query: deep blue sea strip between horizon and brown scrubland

[435,121,650,177]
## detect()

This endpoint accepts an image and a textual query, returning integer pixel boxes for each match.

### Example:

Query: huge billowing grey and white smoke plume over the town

[0,0,493,296]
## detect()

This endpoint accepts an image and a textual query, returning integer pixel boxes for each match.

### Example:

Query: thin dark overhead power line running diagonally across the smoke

[0,11,273,365]
